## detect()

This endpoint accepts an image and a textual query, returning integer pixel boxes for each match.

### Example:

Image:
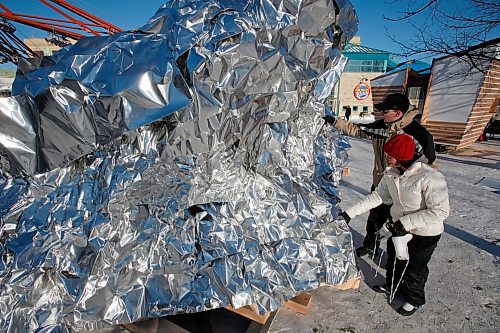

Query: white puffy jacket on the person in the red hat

[345,162,450,236]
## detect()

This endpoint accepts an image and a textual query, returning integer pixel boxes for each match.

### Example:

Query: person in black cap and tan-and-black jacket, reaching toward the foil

[325,93,436,257]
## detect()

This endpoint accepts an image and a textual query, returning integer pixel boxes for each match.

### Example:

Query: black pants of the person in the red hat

[385,235,441,306]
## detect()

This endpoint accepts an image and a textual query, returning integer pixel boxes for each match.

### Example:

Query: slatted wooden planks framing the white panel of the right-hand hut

[422,60,500,149]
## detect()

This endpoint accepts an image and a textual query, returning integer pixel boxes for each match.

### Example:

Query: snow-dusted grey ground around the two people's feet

[269,138,500,333]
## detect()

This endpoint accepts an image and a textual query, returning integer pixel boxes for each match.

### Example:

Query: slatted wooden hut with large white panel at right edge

[422,39,500,149]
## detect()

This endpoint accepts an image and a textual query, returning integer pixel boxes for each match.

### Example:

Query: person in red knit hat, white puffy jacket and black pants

[339,134,450,316]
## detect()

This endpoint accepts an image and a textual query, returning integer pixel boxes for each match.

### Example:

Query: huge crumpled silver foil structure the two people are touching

[0,0,357,332]
